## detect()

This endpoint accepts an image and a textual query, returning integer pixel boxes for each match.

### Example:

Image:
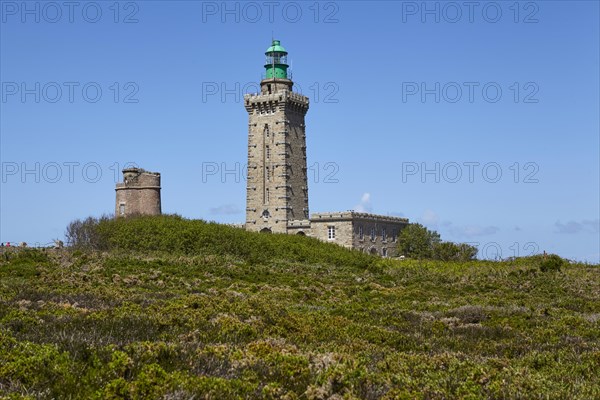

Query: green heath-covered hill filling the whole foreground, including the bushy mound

[0,217,600,399]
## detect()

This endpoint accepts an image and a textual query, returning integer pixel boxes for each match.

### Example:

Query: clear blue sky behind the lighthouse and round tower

[0,1,600,263]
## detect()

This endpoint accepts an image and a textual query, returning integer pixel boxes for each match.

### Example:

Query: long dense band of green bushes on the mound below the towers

[67,215,377,268]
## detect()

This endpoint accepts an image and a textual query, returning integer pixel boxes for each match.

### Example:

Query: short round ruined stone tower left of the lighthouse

[115,168,161,217]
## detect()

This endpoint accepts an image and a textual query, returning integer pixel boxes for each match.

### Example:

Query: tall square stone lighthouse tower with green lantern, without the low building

[244,40,310,234]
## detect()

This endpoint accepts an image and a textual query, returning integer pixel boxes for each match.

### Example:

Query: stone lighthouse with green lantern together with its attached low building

[244,40,408,257]
